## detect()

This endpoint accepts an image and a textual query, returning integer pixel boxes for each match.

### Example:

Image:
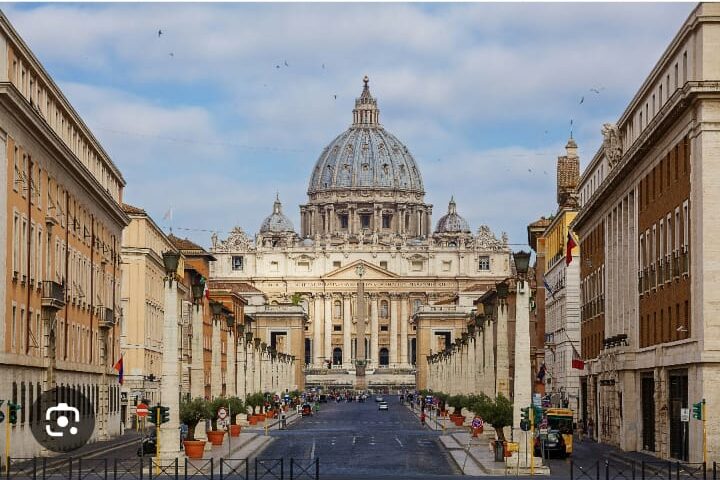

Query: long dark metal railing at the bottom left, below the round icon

[0,457,320,480]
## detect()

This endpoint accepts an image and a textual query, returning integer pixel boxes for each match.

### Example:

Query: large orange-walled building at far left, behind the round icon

[0,13,128,457]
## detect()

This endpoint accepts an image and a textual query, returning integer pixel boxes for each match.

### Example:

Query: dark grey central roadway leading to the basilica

[259,397,459,480]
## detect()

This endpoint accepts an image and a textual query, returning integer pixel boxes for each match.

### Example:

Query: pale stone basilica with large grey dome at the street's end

[210,77,512,388]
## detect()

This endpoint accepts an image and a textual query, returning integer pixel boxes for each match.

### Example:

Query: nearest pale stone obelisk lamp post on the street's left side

[157,251,184,460]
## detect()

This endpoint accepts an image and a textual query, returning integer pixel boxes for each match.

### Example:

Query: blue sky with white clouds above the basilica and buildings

[0,3,695,249]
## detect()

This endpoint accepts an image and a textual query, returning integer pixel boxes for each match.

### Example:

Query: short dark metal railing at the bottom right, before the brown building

[570,460,720,480]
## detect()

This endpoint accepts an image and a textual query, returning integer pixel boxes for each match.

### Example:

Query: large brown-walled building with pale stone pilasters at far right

[572,3,720,462]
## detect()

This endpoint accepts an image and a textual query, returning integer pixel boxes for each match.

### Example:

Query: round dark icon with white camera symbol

[30,386,95,453]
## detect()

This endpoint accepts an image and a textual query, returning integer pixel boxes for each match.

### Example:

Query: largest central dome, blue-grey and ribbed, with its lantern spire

[308,76,425,195]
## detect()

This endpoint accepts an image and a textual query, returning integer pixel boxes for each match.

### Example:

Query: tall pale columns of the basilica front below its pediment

[309,293,412,368]
